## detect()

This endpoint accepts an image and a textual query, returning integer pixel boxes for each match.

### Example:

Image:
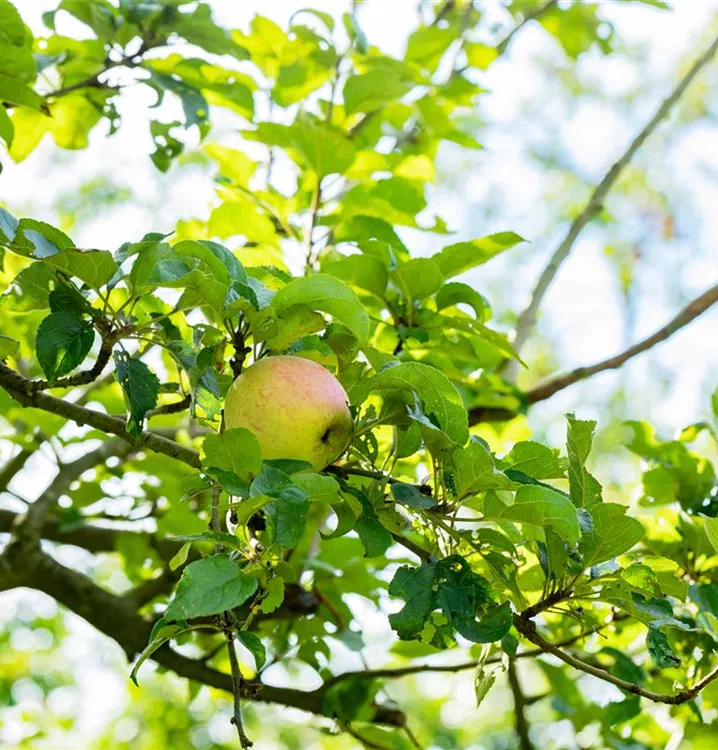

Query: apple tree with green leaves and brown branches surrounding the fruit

[0,0,718,750]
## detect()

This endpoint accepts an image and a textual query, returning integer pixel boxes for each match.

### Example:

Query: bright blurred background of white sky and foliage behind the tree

[0,0,718,750]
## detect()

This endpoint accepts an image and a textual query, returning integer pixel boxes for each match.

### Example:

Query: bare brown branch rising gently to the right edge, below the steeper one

[526,284,718,404]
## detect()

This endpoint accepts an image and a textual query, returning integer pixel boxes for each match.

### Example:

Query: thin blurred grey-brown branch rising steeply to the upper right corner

[514,30,718,366]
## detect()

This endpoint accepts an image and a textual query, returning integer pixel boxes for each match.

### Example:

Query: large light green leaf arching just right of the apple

[373,362,469,445]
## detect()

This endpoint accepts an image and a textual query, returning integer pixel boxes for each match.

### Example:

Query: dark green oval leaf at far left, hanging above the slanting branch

[35,312,95,383]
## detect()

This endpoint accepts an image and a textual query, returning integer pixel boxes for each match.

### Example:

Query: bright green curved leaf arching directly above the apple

[272,273,369,343]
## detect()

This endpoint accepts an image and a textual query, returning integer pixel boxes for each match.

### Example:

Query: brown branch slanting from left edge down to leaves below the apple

[0,362,200,469]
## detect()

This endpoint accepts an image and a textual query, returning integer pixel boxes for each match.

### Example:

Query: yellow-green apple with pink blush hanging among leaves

[224,355,354,471]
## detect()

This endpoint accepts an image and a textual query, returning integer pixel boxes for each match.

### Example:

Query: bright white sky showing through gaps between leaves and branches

[0,0,718,750]
